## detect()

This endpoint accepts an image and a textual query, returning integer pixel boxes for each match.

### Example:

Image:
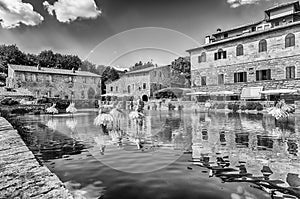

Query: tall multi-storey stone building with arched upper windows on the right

[188,1,300,99]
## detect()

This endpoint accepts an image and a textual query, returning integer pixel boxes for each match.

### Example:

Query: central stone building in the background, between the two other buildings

[106,59,189,101]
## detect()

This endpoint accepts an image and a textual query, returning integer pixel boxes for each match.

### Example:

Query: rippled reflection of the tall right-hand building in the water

[191,113,300,198]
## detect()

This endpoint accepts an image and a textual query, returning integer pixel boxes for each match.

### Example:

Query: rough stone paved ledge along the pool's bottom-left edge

[0,117,73,199]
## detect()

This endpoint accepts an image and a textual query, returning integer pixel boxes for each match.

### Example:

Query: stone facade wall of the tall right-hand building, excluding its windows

[191,22,300,92]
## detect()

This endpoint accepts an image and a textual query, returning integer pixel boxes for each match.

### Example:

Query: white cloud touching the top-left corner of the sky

[0,0,44,29]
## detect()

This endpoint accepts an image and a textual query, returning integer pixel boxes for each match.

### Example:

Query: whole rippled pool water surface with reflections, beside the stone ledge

[17,111,300,199]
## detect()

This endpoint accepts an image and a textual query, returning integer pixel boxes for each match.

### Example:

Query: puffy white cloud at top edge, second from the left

[43,0,101,23]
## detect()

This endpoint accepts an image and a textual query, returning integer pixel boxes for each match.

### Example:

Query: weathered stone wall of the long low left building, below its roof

[8,72,101,99]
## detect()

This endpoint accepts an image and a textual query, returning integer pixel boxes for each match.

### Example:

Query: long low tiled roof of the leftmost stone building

[9,64,101,77]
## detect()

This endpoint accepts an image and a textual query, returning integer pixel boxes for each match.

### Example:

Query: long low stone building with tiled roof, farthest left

[6,65,101,100]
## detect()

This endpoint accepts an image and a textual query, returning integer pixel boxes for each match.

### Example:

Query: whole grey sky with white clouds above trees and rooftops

[0,0,288,67]
